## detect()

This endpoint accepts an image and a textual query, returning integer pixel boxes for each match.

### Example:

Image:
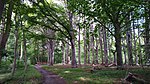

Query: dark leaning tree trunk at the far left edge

[0,0,13,63]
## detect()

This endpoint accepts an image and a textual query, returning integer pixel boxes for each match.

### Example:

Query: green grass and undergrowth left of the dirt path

[0,66,42,84]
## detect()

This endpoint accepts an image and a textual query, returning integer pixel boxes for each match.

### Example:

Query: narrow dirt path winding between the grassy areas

[35,64,66,84]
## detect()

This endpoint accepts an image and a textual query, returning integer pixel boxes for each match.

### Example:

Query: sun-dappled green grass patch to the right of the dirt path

[43,66,150,84]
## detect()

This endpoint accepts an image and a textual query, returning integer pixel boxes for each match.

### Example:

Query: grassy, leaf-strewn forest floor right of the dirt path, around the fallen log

[42,64,150,84]
